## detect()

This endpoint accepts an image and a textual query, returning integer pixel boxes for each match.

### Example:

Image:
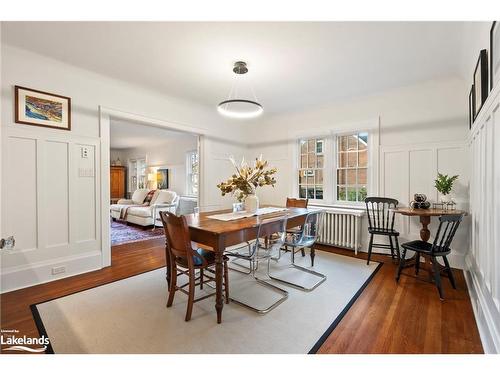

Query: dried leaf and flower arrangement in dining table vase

[217,155,278,202]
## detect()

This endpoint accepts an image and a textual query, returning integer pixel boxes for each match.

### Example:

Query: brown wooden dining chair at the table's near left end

[160,211,229,321]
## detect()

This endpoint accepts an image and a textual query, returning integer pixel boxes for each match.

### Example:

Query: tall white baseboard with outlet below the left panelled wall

[0,251,102,293]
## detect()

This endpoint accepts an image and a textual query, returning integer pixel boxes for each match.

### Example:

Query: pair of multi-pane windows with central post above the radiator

[296,131,371,204]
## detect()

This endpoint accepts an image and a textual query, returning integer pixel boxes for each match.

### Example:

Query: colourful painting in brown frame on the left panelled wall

[15,86,71,130]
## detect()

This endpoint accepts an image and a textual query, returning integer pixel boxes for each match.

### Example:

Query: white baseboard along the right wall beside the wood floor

[464,257,500,354]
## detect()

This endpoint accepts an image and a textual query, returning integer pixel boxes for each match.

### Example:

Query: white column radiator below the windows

[318,209,363,254]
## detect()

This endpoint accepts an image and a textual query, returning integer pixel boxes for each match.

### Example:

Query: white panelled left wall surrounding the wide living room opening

[0,44,245,291]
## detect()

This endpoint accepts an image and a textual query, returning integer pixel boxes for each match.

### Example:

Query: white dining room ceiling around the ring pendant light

[2,22,464,114]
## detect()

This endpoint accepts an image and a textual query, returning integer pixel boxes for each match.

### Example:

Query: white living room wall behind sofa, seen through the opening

[111,135,198,195]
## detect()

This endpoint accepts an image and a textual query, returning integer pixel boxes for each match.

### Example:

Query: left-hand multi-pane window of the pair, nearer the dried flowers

[298,138,325,199]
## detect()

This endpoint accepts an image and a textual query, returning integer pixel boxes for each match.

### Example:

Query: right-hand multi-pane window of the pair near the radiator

[336,133,368,202]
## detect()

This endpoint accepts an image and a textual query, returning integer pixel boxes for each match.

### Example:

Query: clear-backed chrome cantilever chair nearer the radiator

[269,211,326,292]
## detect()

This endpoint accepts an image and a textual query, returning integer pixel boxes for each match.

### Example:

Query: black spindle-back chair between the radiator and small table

[365,197,400,264]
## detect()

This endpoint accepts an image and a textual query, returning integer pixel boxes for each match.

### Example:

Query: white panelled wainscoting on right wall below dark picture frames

[466,85,500,353]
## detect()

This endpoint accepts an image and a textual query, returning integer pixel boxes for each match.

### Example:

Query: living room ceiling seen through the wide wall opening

[110,118,198,149]
